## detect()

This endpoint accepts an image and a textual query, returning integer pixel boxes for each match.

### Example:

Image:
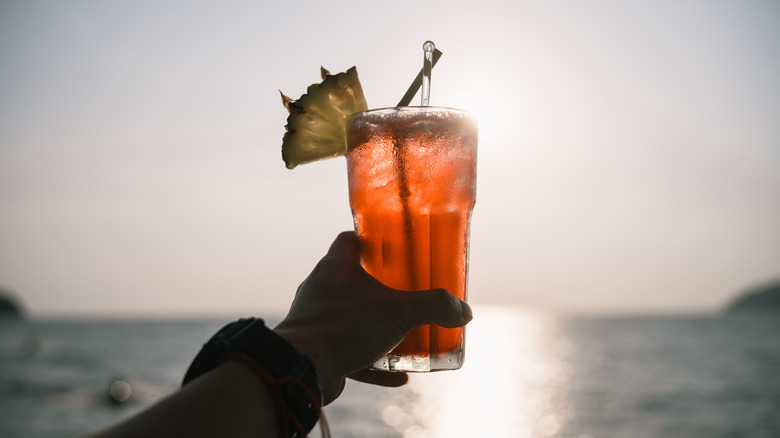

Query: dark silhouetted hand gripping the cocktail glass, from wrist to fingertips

[274,232,472,404]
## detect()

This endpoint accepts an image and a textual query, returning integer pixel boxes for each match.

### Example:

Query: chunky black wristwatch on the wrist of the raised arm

[182,318,322,436]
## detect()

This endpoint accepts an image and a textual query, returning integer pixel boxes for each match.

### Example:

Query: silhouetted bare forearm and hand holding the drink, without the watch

[88,232,471,438]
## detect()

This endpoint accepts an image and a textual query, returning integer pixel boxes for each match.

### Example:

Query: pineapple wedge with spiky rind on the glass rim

[282,67,368,169]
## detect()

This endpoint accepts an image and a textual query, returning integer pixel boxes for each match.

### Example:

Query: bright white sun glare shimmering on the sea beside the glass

[394,307,572,438]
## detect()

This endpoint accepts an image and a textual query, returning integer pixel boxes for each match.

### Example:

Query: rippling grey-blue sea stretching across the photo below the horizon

[0,306,780,438]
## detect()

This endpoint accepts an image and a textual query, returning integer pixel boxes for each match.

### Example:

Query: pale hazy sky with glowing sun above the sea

[0,0,780,317]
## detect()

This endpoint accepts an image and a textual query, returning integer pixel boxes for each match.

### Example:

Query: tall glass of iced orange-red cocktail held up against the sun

[347,107,477,372]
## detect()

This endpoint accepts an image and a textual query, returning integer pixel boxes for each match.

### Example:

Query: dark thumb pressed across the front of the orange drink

[395,289,473,331]
